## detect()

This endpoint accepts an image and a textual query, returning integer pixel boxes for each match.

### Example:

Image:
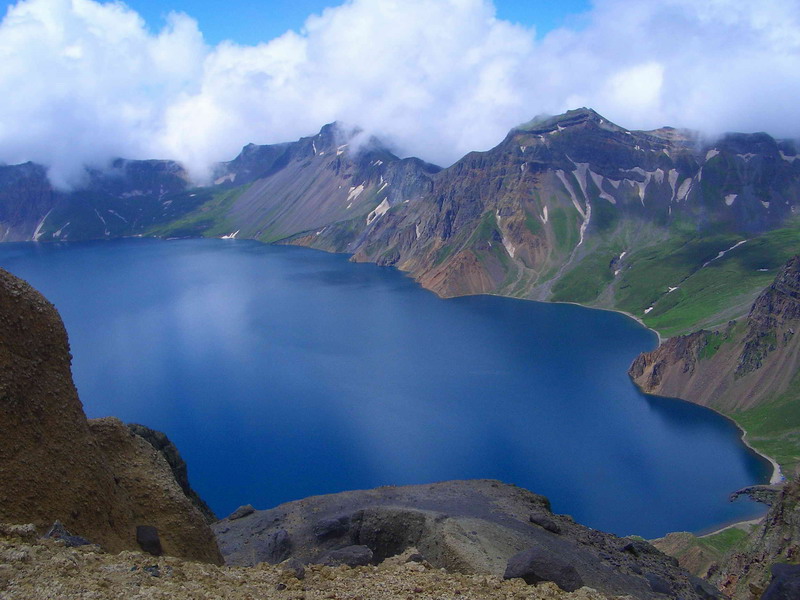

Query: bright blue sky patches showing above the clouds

[4,0,590,45]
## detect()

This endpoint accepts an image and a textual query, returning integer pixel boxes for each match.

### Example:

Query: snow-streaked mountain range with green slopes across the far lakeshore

[0,108,800,474]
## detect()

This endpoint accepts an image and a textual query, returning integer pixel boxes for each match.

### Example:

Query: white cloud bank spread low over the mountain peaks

[0,0,800,186]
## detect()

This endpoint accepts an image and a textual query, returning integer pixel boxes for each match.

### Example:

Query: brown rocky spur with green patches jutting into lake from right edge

[629,256,800,413]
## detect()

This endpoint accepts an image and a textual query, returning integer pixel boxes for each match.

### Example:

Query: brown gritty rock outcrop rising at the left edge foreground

[0,270,220,562]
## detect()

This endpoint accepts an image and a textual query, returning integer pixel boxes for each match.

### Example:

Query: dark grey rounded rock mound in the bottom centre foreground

[214,480,714,600]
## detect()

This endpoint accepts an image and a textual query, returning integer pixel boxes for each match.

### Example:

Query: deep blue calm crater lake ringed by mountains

[0,240,770,537]
